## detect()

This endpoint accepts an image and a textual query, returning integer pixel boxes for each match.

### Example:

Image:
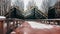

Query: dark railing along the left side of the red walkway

[0,18,24,34]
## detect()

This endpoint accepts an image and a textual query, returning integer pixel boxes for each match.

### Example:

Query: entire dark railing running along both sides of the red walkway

[0,18,60,34]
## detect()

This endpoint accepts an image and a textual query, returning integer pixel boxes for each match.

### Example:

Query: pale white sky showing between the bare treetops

[11,0,57,12]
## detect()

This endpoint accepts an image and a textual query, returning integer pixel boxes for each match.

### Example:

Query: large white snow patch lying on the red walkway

[27,21,53,29]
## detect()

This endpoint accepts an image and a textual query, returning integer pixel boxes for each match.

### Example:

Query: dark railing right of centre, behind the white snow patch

[25,19,60,25]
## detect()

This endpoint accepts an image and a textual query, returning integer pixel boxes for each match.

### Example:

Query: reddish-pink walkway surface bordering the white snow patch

[11,23,60,34]
